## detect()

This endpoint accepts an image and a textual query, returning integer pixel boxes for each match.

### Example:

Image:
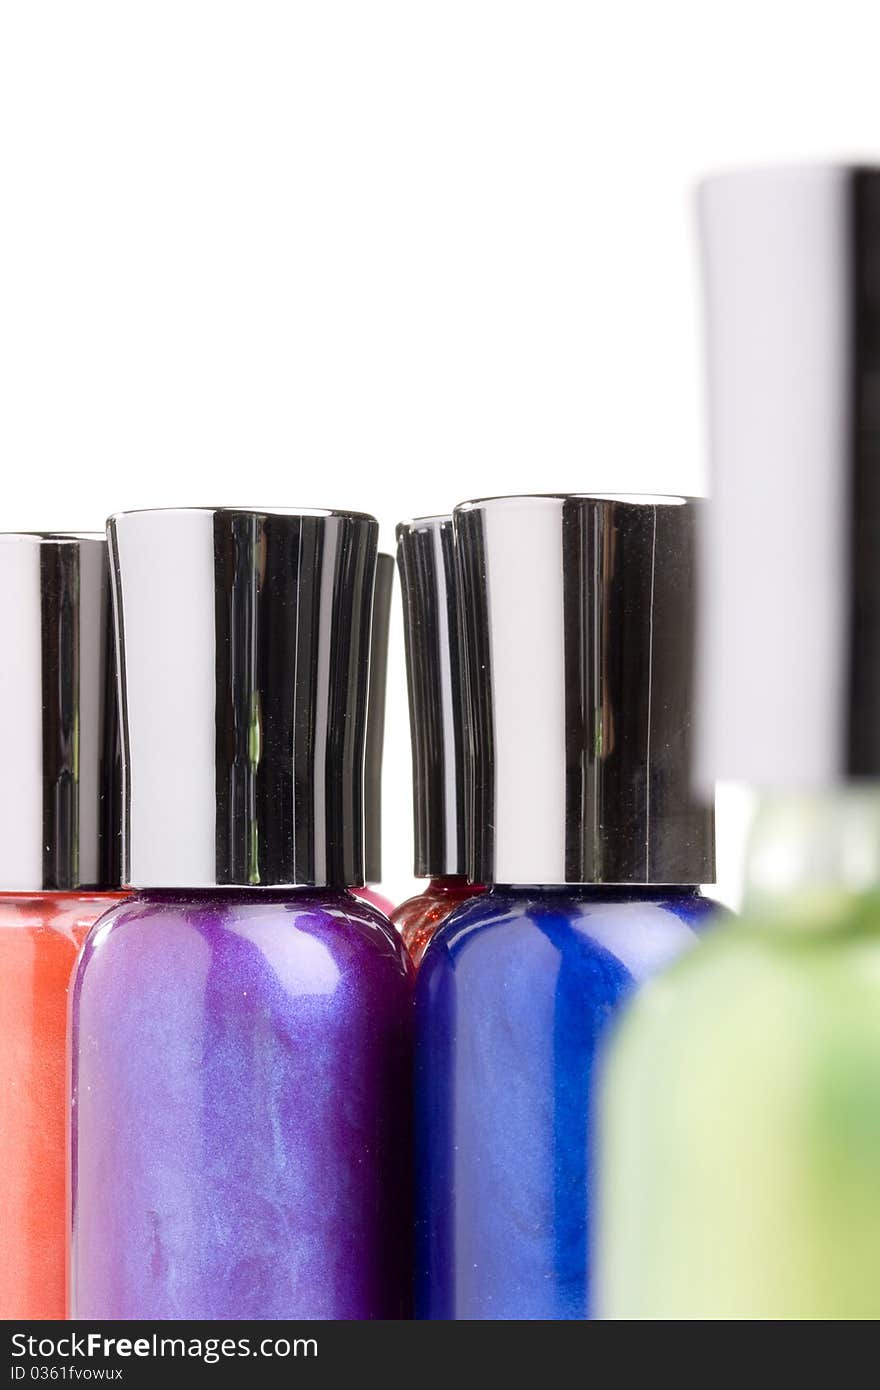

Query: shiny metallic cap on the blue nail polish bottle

[455,493,715,884]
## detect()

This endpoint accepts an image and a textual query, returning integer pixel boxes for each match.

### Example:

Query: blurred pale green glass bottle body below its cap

[599,790,880,1319]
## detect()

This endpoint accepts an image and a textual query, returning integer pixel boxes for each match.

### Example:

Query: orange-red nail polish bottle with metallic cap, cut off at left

[0,534,120,1321]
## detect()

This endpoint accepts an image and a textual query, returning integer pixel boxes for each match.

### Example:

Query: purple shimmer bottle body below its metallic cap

[72,890,410,1319]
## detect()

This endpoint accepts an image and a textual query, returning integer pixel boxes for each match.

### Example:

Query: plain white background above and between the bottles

[0,0,880,901]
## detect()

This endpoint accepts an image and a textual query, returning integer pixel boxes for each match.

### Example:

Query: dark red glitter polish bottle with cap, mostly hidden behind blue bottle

[392,517,482,965]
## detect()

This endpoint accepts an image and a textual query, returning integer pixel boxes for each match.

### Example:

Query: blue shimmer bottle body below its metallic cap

[416,888,716,1319]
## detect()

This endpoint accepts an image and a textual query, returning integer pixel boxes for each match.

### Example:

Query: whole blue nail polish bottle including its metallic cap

[416,495,713,1319]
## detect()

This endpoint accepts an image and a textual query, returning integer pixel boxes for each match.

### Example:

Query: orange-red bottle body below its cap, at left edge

[0,892,120,1321]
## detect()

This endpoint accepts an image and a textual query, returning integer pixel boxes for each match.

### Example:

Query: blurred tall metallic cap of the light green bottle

[698,165,880,788]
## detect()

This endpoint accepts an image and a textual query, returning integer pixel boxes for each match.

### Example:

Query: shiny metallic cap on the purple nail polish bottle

[108,507,378,888]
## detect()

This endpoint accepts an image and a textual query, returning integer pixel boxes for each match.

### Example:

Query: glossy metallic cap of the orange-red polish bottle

[0,534,120,892]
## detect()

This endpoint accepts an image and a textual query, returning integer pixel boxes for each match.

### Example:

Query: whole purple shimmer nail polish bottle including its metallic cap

[71,509,412,1321]
